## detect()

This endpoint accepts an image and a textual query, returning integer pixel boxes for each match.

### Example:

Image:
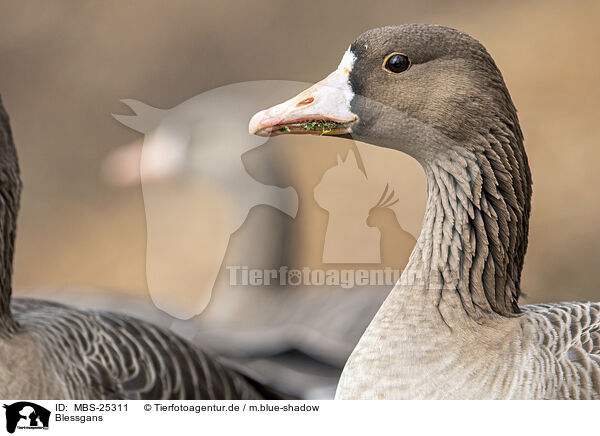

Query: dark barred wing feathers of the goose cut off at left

[12,299,284,400]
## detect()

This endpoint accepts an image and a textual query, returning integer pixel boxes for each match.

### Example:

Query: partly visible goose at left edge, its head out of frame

[0,95,282,399]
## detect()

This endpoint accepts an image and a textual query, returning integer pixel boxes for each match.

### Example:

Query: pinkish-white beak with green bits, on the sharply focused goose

[248,56,358,136]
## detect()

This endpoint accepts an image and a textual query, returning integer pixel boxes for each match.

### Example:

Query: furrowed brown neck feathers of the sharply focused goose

[400,124,531,318]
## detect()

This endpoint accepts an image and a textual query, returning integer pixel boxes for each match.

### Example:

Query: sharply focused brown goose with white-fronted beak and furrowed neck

[249,24,600,399]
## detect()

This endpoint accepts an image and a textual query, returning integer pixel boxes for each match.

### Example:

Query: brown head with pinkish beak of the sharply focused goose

[249,24,521,161]
